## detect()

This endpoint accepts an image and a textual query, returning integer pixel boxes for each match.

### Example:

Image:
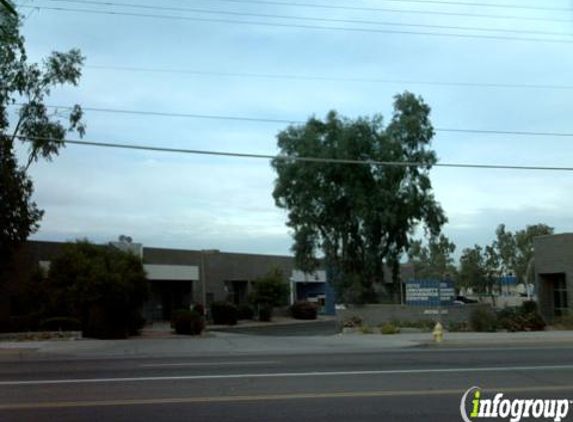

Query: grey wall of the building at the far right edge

[533,233,573,321]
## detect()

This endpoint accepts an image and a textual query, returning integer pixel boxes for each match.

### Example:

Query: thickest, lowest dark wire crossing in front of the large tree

[17,135,573,172]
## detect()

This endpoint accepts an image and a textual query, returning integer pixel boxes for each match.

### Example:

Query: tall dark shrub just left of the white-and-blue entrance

[250,268,290,319]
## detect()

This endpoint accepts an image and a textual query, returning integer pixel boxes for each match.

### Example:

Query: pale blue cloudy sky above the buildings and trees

[10,0,573,254]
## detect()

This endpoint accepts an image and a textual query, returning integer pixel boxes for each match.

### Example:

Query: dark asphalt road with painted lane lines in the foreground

[0,345,573,422]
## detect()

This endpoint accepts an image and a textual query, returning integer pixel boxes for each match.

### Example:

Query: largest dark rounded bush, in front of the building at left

[47,240,149,338]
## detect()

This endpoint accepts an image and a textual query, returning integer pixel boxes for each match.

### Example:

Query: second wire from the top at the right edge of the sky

[203,0,571,23]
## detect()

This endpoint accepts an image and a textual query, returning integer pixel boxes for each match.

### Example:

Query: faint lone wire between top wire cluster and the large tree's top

[85,65,573,90]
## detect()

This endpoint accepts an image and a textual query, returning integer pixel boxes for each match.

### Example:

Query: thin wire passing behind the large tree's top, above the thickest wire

[39,103,573,137]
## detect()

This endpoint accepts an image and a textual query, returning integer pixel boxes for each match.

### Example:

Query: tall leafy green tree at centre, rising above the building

[272,92,446,302]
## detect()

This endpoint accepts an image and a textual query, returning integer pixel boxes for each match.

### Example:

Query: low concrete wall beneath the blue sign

[336,304,489,326]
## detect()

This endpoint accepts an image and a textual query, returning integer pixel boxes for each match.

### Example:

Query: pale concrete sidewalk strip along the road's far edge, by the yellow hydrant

[0,331,573,360]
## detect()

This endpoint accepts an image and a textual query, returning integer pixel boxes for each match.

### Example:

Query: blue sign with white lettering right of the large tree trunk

[406,279,456,307]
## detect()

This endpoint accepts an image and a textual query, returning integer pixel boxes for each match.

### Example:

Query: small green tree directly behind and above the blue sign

[408,234,457,280]
